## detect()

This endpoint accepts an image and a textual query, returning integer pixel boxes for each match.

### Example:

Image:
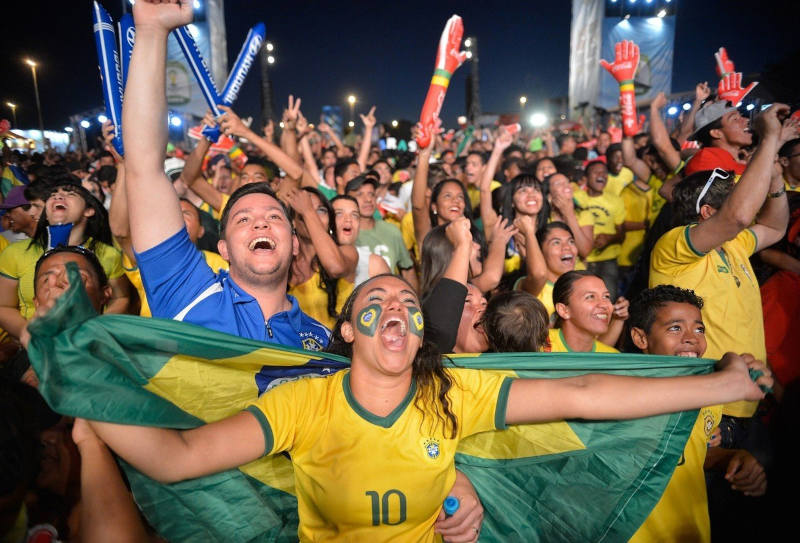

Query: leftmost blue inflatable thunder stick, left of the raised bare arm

[92,2,124,155]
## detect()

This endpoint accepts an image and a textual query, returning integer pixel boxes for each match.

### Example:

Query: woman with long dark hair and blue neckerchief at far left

[0,171,131,338]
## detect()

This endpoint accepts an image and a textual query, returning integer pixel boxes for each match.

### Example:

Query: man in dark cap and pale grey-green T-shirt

[345,174,417,289]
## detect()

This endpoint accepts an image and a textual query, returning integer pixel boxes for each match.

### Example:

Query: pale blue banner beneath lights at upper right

[595,16,675,110]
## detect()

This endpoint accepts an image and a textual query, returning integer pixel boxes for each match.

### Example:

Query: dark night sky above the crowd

[0,0,800,133]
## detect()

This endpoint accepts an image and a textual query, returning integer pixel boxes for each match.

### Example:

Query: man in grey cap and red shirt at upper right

[684,100,753,176]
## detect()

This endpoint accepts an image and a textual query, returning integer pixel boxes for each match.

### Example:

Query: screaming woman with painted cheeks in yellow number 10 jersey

[90,275,772,542]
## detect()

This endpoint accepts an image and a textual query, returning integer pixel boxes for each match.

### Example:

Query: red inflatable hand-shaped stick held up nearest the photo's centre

[417,15,467,149]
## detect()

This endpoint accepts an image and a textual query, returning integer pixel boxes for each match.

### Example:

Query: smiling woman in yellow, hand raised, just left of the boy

[550,270,629,353]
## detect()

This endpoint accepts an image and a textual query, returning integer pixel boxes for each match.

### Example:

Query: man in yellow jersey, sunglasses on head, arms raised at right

[650,104,798,417]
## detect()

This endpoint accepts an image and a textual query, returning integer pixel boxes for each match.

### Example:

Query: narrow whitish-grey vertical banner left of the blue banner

[568,0,613,113]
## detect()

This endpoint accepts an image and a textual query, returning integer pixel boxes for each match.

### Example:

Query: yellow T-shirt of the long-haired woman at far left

[0,239,125,319]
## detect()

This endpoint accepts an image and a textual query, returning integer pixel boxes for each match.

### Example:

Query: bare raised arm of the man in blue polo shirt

[122,0,192,253]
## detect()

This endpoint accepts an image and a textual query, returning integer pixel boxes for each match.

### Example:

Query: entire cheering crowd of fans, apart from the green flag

[0,2,800,542]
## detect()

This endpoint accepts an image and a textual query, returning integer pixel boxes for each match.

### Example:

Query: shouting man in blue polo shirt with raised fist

[122,5,329,350]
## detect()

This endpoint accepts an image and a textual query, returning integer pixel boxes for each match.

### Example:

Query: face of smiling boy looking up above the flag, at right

[631,302,706,358]
